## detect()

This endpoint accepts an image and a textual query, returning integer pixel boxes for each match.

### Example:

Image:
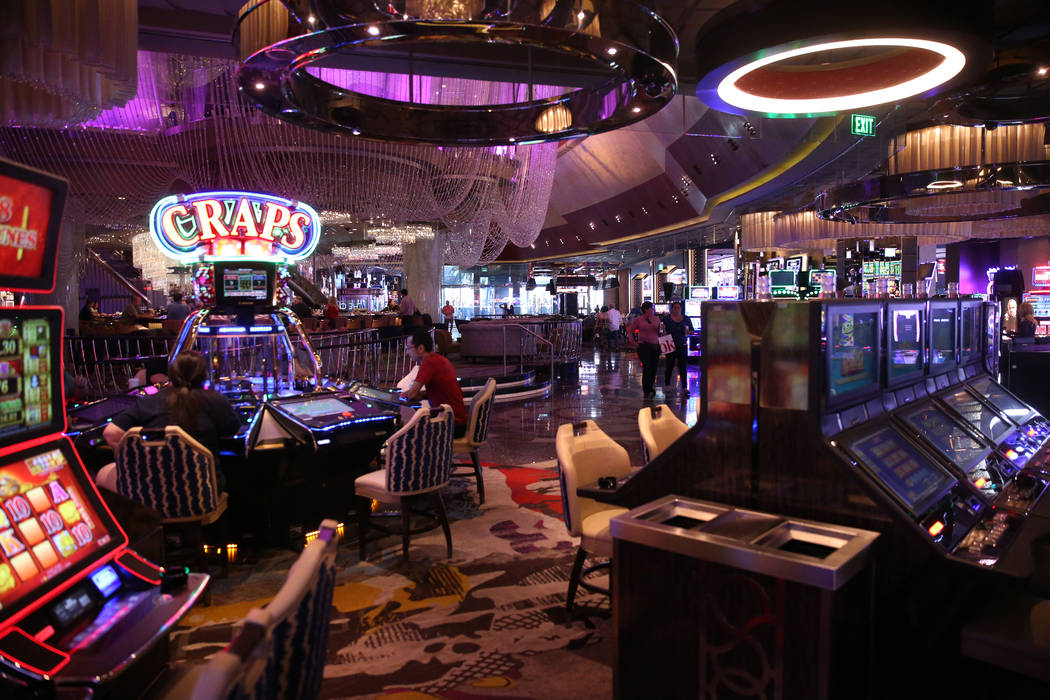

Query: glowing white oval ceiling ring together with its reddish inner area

[697,37,966,116]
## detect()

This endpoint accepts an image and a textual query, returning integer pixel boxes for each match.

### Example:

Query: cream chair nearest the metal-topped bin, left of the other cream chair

[554,421,631,613]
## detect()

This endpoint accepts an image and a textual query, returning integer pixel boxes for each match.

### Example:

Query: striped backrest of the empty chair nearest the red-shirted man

[386,404,454,495]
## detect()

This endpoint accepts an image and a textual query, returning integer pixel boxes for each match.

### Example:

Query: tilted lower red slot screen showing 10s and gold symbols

[0,440,126,628]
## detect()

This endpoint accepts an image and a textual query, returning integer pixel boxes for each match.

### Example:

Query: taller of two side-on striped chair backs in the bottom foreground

[248,521,339,698]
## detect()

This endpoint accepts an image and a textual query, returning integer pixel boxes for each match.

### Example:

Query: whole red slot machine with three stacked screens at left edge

[0,161,208,698]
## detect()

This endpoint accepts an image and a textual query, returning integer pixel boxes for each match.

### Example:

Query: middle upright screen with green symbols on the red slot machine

[0,307,65,447]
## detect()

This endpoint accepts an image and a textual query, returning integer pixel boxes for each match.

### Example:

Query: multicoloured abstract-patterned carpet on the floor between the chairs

[173,465,613,700]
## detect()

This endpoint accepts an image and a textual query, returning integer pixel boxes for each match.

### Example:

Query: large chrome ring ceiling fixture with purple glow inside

[234,0,678,146]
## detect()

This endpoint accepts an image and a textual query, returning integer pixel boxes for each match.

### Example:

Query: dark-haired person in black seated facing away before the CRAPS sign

[96,351,240,491]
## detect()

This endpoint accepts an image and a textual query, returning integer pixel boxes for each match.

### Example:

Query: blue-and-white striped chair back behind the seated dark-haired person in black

[116,425,219,519]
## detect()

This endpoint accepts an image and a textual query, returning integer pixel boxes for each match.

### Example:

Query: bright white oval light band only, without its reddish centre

[718,38,966,113]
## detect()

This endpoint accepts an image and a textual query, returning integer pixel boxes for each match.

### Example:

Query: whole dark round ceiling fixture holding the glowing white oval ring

[696,0,991,118]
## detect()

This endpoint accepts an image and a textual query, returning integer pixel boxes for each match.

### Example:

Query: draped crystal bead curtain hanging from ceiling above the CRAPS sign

[0,51,558,266]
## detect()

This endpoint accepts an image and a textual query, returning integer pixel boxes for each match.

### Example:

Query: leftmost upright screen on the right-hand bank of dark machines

[825,306,879,399]
